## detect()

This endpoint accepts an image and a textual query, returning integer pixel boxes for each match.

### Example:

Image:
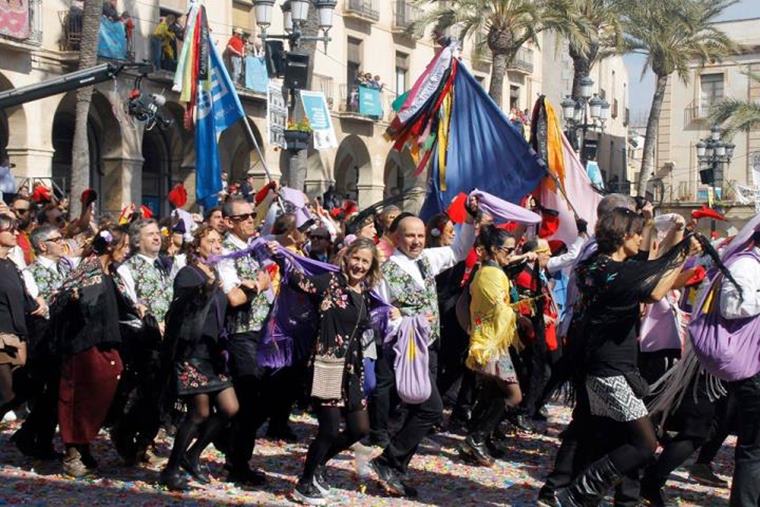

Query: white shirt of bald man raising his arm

[377,223,475,334]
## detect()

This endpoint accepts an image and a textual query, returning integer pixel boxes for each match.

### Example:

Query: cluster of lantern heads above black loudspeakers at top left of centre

[253,0,338,51]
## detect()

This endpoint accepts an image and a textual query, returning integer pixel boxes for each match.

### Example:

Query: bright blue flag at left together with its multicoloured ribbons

[173,3,245,209]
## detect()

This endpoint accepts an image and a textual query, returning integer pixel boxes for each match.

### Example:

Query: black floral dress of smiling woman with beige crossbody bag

[288,270,371,413]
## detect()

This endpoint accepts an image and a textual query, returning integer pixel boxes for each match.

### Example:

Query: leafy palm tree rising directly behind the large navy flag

[410,0,544,107]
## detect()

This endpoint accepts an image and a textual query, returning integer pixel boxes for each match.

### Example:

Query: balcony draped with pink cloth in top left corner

[0,0,42,50]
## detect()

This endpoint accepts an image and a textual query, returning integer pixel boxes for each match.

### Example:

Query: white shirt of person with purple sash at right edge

[720,247,760,319]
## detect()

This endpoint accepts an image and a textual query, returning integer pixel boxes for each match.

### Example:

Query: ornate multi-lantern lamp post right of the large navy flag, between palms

[560,76,610,165]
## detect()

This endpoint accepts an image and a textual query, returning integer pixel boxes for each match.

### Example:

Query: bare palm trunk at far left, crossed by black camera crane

[69,0,103,216]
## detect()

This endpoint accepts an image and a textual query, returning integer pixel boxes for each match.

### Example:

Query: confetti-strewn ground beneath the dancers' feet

[0,406,735,507]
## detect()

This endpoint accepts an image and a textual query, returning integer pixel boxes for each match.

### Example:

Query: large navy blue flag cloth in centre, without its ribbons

[420,65,546,218]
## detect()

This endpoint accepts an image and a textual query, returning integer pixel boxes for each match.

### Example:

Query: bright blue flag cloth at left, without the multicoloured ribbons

[195,37,245,210]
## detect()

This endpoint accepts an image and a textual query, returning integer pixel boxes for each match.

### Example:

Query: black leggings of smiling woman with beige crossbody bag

[299,406,369,484]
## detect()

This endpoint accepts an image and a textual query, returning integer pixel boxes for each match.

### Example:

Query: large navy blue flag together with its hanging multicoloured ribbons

[386,44,546,218]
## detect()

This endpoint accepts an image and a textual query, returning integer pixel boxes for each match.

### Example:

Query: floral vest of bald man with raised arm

[381,256,441,343]
